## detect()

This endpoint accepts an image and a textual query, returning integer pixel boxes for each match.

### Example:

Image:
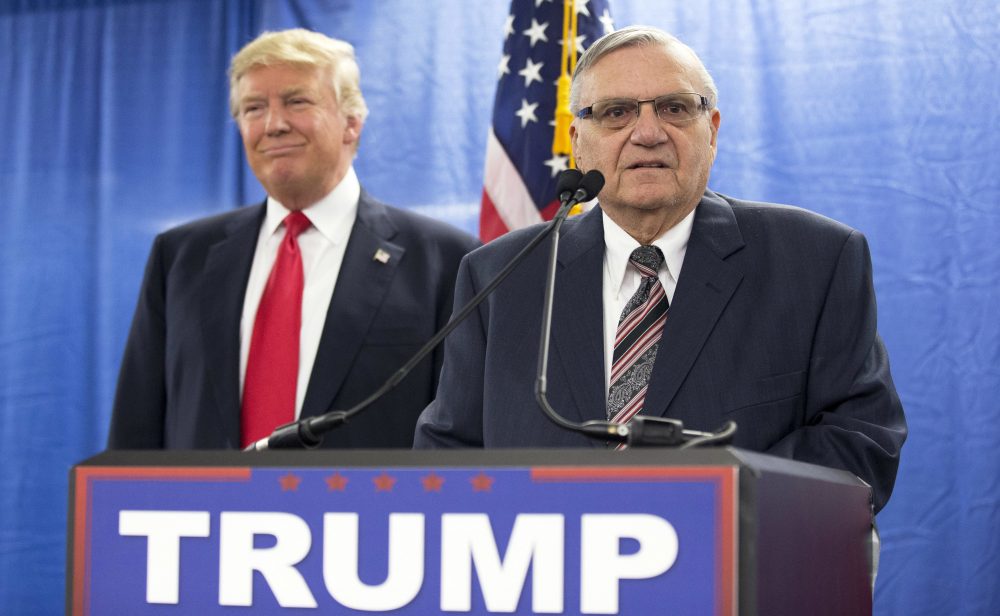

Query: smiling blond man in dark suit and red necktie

[108,30,478,449]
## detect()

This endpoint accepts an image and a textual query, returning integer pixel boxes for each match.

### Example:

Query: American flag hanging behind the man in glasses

[479,0,614,242]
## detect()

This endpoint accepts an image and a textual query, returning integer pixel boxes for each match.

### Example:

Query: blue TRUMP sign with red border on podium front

[67,454,739,616]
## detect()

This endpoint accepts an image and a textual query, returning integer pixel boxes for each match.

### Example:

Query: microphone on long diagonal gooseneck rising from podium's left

[243,169,592,451]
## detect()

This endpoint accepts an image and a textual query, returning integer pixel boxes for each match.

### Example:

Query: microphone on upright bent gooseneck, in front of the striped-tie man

[535,169,736,449]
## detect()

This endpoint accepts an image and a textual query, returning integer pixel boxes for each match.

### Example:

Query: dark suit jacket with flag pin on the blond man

[108,191,478,449]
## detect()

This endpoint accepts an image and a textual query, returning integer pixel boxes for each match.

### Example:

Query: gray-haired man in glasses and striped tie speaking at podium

[415,27,906,510]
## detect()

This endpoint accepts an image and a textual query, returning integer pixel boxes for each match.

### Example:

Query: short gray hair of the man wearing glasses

[569,26,719,114]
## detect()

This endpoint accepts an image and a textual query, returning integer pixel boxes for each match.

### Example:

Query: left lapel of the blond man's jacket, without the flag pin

[201,205,264,447]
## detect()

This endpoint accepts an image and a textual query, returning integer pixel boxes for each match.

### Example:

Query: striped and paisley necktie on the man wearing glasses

[608,246,669,430]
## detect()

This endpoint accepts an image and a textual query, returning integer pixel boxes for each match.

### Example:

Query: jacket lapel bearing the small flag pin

[302,191,406,417]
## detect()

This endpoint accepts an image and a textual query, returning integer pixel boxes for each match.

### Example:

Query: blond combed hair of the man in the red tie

[229,28,368,122]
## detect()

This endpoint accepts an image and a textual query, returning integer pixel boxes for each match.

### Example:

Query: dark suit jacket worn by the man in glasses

[415,191,906,509]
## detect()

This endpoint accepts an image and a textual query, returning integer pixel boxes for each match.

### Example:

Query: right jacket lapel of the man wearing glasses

[645,191,744,415]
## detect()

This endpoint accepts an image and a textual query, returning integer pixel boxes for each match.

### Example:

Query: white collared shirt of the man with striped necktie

[601,208,697,400]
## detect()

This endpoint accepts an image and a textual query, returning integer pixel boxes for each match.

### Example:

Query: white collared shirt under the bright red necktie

[240,167,361,419]
